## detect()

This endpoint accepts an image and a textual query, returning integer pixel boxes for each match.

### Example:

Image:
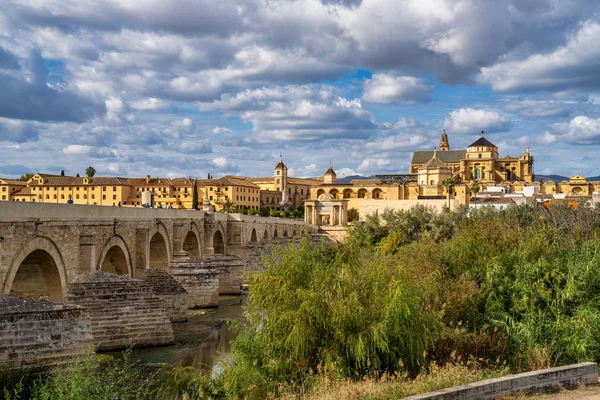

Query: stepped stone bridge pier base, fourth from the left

[169,257,219,308]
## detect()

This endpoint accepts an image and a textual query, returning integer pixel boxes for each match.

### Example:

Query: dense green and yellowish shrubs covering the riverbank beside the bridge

[4,203,600,399]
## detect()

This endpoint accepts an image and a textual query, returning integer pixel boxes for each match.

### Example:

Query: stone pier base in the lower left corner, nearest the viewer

[0,294,92,369]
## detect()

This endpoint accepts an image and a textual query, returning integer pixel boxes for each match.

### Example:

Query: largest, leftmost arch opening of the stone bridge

[2,236,67,302]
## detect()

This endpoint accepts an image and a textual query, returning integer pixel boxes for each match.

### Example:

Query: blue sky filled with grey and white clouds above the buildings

[0,0,600,178]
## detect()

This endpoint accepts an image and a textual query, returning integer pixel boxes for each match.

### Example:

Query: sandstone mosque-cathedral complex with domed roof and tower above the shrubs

[311,130,600,209]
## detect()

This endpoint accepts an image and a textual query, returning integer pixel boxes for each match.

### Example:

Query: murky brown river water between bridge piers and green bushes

[104,295,246,371]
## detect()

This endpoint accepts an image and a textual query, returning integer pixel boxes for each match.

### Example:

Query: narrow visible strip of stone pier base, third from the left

[142,269,188,322]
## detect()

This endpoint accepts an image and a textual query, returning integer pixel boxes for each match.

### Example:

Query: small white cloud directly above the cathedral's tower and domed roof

[444,108,510,135]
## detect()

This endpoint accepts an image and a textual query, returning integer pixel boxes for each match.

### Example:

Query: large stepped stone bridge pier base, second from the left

[65,272,174,350]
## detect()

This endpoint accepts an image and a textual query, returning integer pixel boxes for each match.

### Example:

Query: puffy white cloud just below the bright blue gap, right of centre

[363,74,433,104]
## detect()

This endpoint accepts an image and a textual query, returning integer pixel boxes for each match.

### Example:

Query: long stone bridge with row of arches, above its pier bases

[0,202,316,302]
